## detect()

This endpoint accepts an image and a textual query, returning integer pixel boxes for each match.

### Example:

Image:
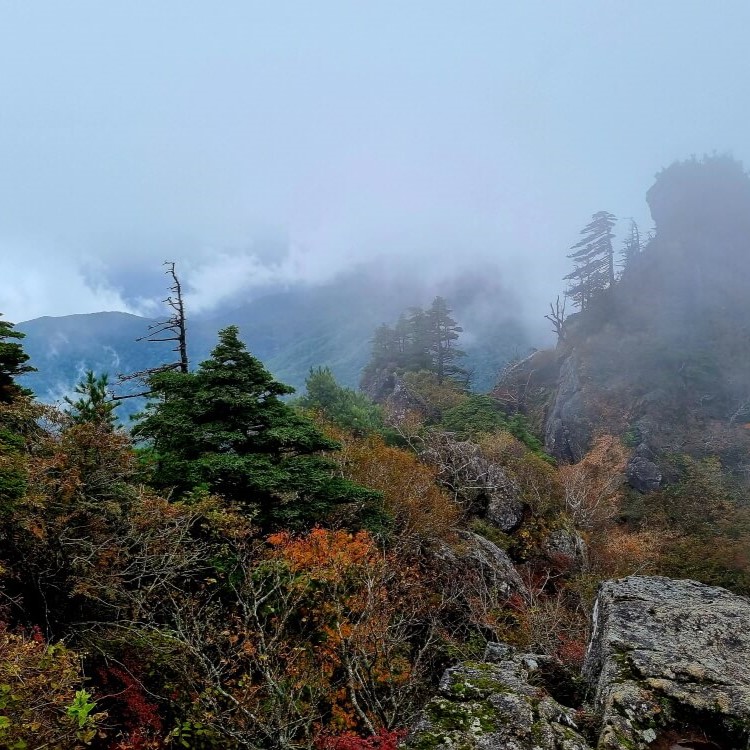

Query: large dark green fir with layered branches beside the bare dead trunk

[133,326,383,531]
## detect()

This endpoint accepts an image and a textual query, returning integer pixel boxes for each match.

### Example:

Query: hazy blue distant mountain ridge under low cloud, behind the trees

[17,271,529,411]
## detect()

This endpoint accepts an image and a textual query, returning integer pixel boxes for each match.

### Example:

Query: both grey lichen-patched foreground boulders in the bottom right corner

[405,576,750,750]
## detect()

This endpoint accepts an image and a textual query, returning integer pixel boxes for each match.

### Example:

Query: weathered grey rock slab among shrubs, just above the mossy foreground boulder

[436,531,526,598]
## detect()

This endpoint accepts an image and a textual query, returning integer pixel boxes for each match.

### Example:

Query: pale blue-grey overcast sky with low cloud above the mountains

[0,0,750,321]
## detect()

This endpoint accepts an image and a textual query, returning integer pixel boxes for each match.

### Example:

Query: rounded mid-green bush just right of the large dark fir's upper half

[297,367,383,435]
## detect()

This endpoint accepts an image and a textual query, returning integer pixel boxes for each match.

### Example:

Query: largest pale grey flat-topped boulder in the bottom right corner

[584,576,750,750]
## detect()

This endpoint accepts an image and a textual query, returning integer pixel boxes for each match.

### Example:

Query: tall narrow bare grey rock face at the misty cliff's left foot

[544,353,592,462]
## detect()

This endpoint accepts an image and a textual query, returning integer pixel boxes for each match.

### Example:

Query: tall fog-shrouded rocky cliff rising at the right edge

[496,157,750,494]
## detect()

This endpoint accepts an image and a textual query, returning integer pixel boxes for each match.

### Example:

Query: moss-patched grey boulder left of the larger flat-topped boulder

[404,643,589,750]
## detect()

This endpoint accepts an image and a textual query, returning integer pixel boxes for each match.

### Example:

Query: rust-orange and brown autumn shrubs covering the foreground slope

[0,306,750,750]
